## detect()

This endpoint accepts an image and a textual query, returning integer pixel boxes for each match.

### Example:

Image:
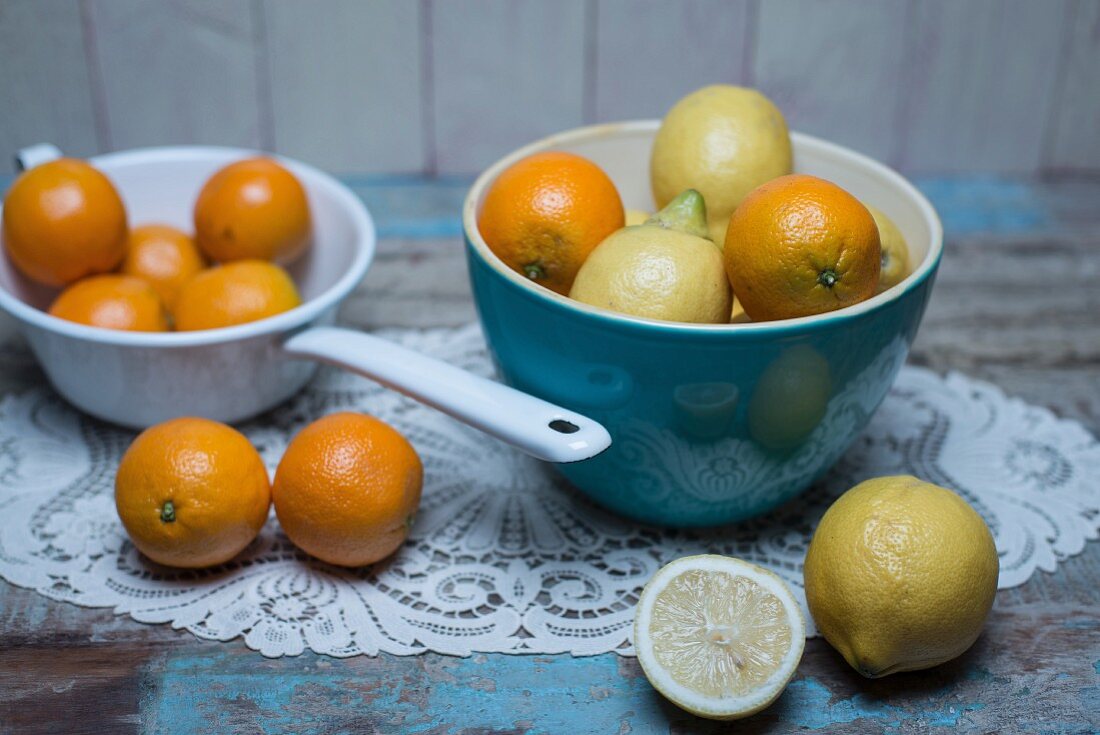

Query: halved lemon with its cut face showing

[634,555,806,720]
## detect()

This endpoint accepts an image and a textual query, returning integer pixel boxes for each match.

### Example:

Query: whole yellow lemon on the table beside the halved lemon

[803,475,998,677]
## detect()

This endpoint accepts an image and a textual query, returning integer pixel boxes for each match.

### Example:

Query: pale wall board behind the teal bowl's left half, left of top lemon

[431,0,585,174]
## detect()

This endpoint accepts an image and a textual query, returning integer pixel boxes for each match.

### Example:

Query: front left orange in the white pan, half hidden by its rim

[50,274,168,332]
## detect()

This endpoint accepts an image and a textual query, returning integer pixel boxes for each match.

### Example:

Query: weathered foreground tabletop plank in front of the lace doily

[0,603,1100,735]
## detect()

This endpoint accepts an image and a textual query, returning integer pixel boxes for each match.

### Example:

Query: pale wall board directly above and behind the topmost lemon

[586,0,754,122]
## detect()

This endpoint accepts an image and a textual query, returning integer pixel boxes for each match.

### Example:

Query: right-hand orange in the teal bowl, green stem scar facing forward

[724,174,881,321]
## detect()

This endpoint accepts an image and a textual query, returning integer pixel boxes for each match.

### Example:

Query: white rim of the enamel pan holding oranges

[0,145,376,348]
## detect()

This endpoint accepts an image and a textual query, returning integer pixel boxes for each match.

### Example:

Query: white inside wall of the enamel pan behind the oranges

[0,146,369,309]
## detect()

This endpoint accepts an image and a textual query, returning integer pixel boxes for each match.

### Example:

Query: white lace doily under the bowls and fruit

[0,326,1100,656]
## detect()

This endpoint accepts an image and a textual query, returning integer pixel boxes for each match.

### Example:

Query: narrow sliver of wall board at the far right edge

[1047,0,1100,171]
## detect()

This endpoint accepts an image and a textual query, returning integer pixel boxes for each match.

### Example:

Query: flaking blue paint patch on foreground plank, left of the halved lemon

[143,646,664,735]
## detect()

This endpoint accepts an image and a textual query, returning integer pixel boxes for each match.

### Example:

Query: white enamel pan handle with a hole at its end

[283,327,612,462]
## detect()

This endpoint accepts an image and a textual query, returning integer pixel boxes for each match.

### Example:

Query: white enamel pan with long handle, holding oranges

[0,145,611,462]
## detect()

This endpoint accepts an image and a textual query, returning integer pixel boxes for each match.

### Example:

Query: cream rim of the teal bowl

[462,119,944,333]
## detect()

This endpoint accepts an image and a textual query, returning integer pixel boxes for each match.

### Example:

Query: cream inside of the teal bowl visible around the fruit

[465,120,942,310]
